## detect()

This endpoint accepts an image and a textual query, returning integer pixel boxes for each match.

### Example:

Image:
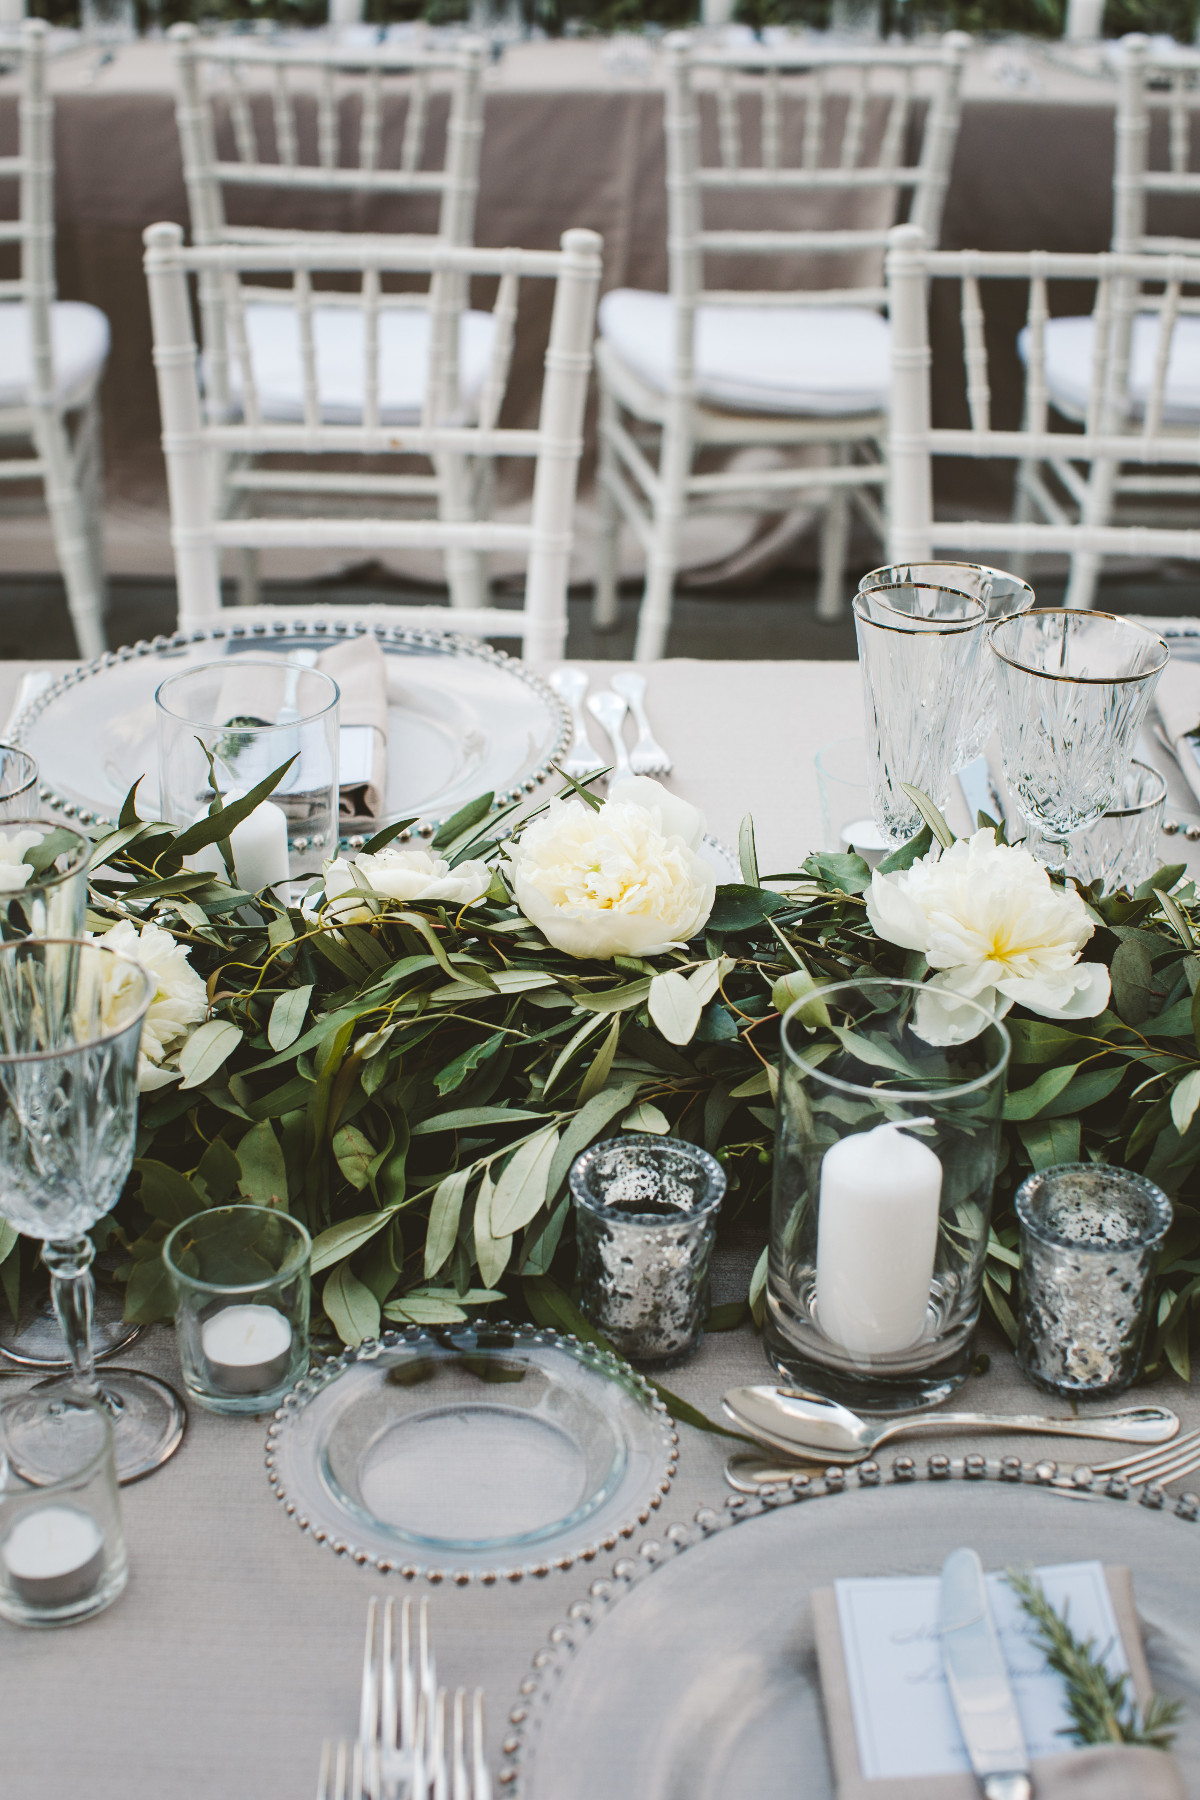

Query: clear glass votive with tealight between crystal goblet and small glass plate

[162,1206,311,1413]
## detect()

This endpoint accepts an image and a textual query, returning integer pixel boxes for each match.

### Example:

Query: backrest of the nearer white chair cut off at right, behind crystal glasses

[887,225,1200,562]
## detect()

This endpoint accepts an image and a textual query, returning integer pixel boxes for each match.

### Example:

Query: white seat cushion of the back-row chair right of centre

[599,288,891,418]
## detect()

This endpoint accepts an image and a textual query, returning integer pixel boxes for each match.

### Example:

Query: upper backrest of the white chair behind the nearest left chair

[171,25,484,245]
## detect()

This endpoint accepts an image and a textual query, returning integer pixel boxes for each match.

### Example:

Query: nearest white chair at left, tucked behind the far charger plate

[146,225,601,659]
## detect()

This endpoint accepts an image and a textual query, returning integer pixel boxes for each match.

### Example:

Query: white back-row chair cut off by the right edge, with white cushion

[1016,34,1200,607]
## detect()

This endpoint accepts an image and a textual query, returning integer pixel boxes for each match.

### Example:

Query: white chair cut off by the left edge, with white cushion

[0,20,108,657]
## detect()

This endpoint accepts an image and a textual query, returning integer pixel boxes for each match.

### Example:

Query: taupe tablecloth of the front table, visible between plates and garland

[0,661,1200,1800]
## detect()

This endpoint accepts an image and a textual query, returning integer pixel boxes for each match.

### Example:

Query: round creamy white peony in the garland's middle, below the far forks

[507,776,716,961]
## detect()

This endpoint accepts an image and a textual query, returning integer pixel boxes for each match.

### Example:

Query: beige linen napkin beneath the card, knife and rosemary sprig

[813,1568,1187,1800]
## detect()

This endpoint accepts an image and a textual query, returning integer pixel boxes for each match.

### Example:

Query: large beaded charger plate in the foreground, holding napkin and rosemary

[500,1456,1200,1800]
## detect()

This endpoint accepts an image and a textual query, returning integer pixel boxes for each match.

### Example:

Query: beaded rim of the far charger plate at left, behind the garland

[9,608,572,850]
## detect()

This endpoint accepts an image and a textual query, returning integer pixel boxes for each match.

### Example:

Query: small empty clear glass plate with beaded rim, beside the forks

[266,1325,678,1584]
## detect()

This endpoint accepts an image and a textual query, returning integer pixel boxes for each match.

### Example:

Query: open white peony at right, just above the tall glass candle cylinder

[867,828,1110,1044]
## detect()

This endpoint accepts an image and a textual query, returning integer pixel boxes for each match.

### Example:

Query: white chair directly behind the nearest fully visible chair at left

[171,25,493,608]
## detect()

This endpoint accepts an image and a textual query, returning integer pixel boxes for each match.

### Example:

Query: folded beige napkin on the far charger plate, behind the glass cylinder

[216,635,387,819]
